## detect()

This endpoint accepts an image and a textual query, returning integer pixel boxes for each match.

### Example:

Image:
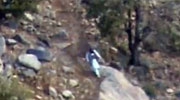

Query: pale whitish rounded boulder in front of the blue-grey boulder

[18,54,41,71]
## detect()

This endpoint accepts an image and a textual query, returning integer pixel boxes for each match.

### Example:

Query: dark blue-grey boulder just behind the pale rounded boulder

[26,47,52,62]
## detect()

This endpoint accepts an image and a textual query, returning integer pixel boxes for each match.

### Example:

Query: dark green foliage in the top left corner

[0,0,40,18]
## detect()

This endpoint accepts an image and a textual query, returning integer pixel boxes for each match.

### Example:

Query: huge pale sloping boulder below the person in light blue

[99,66,149,100]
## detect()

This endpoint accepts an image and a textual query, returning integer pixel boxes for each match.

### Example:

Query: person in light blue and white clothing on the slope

[86,48,103,78]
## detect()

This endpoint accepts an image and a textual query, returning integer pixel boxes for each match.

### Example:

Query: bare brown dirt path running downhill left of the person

[33,0,100,100]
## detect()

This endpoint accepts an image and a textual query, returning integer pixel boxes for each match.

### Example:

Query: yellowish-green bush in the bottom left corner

[0,77,33,100]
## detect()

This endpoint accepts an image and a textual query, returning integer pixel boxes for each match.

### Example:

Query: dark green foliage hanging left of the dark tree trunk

[87,0,124,37]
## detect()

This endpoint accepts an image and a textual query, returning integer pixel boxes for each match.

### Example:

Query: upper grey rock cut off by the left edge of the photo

[0,36,6,57]
